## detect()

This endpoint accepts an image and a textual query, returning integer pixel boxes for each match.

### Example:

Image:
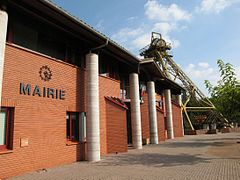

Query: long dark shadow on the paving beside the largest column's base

[97,153,211,167]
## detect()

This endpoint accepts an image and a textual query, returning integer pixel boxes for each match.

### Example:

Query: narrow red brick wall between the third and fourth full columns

[157,109,166,142]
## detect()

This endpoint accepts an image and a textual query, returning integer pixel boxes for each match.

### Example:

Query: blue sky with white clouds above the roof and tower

[53,0,240,93]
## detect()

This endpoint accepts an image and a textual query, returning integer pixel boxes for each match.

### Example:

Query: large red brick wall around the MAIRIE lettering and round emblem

[0,45,85,178]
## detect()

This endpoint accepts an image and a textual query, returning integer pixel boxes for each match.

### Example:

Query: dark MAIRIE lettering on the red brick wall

[20,82,65,100]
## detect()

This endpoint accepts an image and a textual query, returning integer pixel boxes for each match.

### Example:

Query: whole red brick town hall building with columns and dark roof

[0,0,183,178]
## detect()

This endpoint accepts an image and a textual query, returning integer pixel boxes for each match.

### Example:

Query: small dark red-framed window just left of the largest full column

[66,112,79,141]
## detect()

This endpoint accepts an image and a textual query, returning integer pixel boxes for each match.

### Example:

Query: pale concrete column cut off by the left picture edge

[0,10,8,107]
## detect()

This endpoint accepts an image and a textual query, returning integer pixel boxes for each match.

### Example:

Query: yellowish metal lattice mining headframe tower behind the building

[140,32,228,130]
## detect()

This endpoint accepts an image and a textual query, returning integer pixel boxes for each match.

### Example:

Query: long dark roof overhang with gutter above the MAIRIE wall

[7,0,140,65]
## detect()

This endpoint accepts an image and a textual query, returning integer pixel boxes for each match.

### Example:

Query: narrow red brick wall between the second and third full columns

[140,93,150,140]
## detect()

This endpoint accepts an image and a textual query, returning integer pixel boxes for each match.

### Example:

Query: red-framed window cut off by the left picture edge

[0,108,13,150]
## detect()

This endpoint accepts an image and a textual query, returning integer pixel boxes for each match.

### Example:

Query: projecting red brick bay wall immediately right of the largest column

[106,100,128,153]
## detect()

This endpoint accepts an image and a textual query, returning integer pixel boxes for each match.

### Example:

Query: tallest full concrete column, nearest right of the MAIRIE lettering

[86,53,100,161]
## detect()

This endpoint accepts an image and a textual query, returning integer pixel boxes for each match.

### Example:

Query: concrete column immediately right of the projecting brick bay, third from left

[129,73,142,149]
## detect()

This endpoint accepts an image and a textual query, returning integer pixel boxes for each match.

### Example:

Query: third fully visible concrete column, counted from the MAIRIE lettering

[147,81,158,144]
